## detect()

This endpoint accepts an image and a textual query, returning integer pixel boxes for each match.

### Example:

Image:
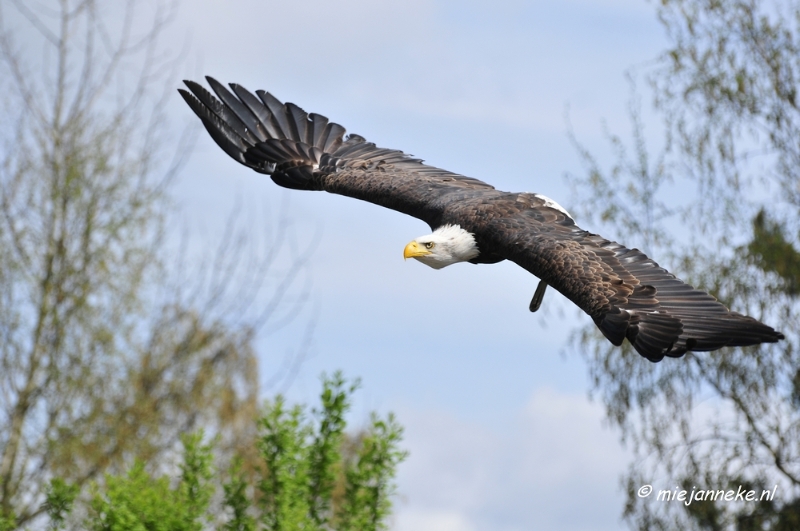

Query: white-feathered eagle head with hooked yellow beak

[403,225,480,269]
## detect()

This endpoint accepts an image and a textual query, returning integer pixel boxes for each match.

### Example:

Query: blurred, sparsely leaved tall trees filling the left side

[0,0,312,527]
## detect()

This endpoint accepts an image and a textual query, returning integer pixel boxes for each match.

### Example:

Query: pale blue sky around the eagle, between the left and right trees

[169,0,664,531]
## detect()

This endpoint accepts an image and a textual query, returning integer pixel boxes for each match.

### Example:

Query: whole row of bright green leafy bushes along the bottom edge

[36,372,406,531]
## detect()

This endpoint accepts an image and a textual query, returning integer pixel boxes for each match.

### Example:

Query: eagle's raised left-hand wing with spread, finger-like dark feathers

[179,77,497,228]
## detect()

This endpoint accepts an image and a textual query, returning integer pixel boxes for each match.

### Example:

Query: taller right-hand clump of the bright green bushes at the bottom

[259,373,406,531]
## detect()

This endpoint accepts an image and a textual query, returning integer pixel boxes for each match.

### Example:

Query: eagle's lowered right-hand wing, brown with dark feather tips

[472,194,783,361]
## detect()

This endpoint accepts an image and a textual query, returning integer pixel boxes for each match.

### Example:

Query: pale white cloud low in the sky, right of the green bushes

[396,388,627,531]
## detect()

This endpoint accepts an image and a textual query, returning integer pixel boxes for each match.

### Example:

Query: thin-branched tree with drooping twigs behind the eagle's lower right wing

[564,0,800,530]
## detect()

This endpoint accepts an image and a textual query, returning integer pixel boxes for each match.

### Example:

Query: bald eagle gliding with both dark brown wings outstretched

[179,77,784,362]
